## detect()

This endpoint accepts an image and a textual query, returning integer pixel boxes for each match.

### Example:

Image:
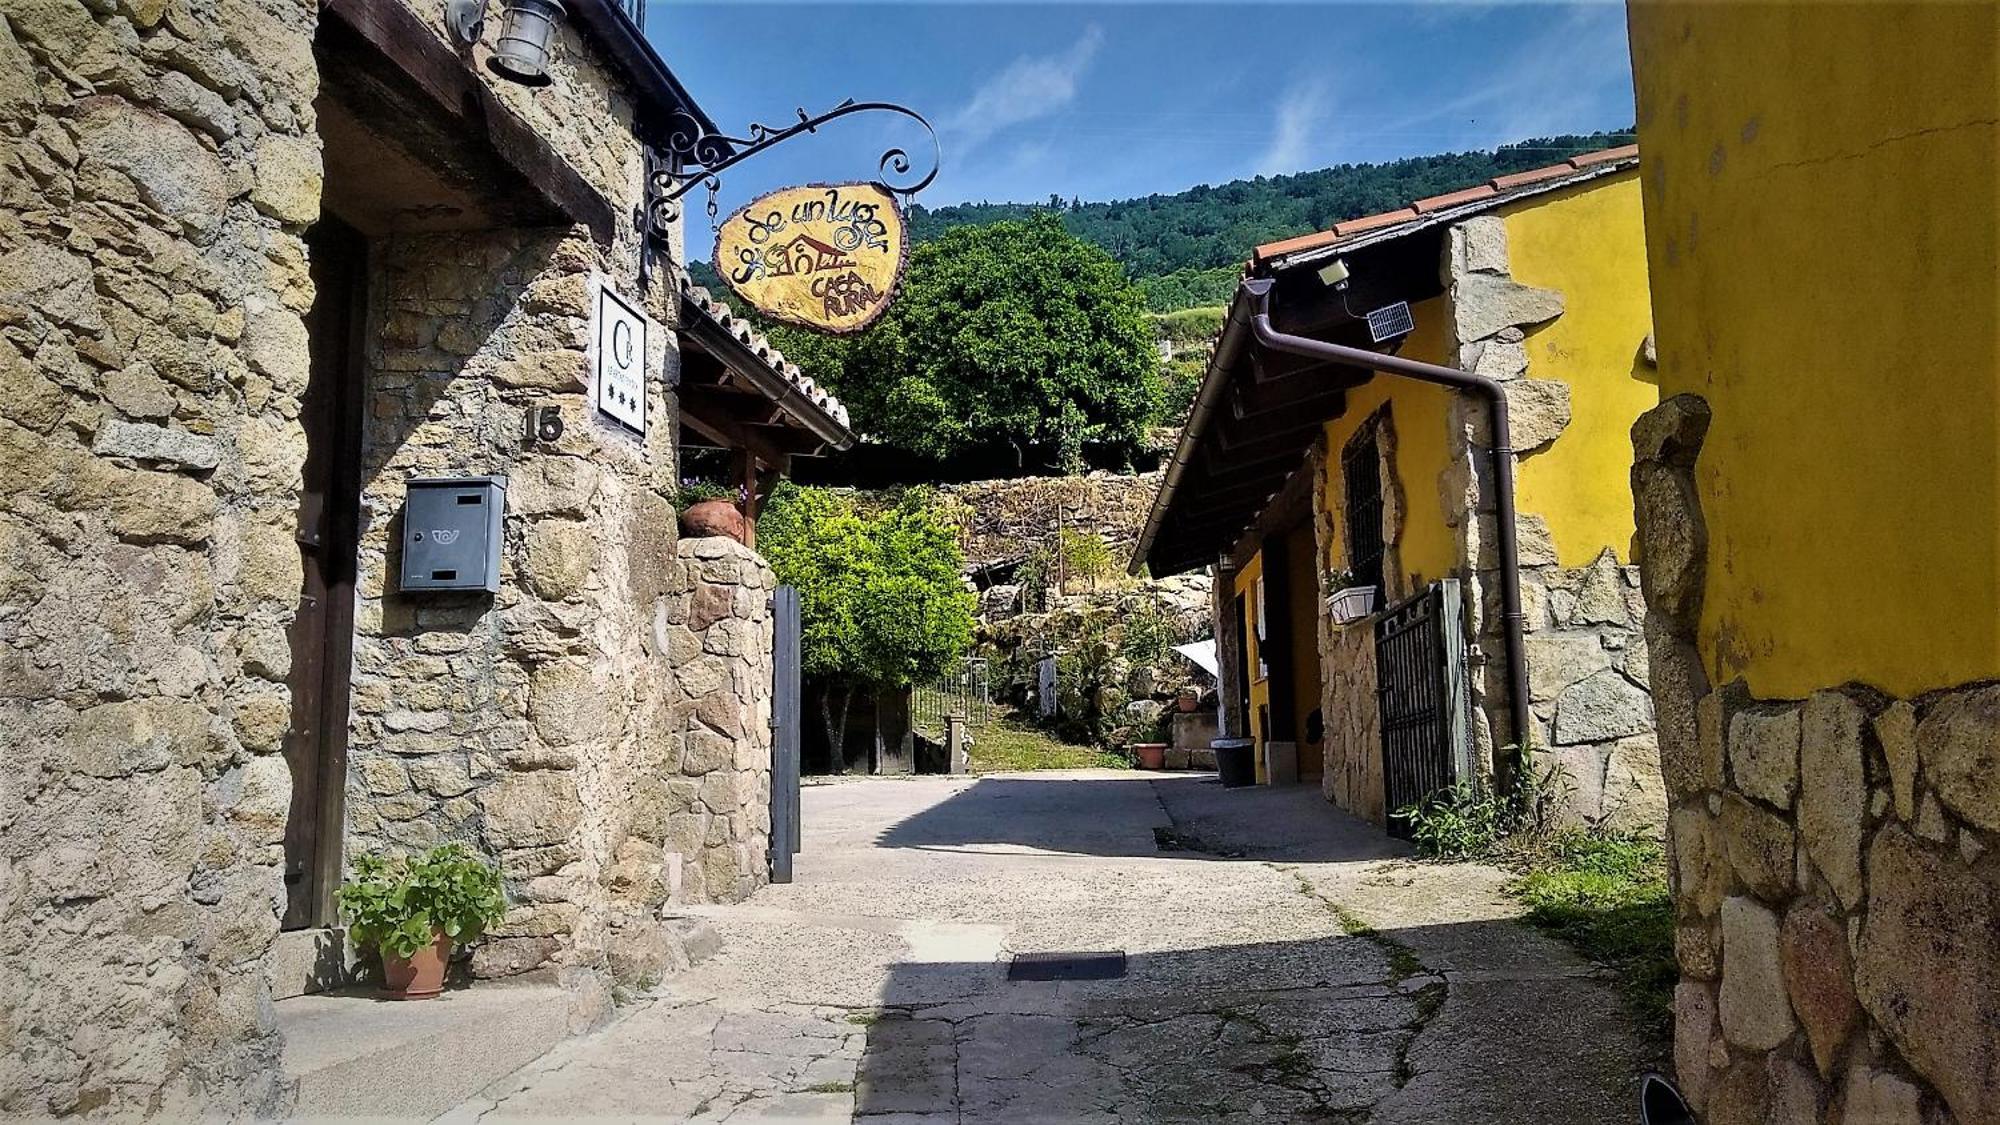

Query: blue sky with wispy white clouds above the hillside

[646,0,1632,216]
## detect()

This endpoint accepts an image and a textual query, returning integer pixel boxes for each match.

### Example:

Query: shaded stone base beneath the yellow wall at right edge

[1632,394,2000,1125]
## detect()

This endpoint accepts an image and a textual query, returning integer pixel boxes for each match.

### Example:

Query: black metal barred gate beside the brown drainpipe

[1376,579,1472,835]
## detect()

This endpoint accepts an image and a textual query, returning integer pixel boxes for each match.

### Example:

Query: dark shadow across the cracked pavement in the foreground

[854,923,1648,1125]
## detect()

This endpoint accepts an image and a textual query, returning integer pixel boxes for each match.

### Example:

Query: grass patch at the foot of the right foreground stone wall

[1496,829,1680,1035]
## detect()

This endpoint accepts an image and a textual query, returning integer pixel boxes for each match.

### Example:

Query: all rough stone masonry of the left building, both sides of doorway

[0,0,770,1115]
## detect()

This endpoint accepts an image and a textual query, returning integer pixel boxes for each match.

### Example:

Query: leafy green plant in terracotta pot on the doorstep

[340,843,506,1001]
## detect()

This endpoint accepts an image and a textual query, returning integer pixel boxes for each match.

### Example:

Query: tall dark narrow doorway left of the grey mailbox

[284,214,368,929]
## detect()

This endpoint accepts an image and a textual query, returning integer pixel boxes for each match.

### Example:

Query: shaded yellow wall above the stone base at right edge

[1630,4,2000,697]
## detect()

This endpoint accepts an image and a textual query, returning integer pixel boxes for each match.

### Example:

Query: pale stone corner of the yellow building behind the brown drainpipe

[1438,214,1664,827]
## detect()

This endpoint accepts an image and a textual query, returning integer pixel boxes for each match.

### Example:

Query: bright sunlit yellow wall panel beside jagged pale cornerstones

[1502,170,1660,567]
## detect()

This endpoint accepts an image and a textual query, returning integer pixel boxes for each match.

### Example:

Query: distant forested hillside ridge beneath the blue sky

[696,132,1632,312]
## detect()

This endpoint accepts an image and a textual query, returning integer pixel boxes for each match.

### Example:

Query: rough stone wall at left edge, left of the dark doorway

[0,0,318,1115]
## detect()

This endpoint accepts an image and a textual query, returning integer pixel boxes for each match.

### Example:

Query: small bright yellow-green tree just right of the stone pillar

[758,484,974,773]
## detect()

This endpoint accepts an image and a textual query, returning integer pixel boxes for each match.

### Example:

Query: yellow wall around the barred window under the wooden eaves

[1326,298,1464,587]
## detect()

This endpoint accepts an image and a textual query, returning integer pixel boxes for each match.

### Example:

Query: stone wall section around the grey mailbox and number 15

[348,223,720,992]
